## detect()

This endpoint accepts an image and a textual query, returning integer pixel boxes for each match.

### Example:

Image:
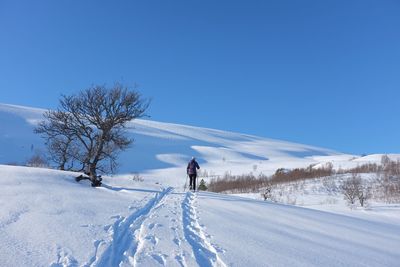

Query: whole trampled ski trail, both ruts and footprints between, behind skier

[85,187,226,267]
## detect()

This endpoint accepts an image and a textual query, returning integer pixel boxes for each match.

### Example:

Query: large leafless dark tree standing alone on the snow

[35,83,150,186]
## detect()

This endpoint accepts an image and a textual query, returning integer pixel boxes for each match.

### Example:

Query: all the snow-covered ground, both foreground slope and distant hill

[0,104,400,267]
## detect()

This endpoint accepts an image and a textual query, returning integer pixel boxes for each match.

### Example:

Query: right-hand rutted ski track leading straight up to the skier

[182,192,226,267]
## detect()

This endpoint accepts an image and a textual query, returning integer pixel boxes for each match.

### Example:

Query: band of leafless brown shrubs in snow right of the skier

[204,157,400,207]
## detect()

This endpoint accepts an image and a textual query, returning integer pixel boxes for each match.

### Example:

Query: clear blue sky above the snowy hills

[0,0,400,154]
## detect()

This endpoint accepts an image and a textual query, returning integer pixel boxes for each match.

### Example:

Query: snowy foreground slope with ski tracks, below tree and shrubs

[0,165,400,267]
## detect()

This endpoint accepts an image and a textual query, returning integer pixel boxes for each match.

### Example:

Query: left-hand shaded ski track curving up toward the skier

[90,187,172,267]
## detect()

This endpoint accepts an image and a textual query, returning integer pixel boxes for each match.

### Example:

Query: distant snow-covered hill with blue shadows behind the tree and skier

[0,104,397,186]
